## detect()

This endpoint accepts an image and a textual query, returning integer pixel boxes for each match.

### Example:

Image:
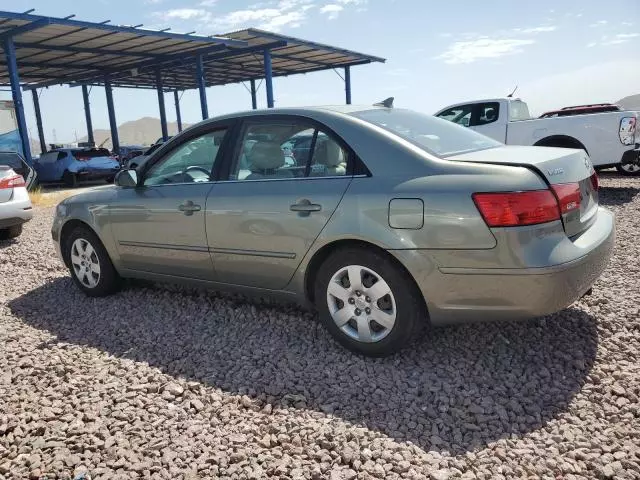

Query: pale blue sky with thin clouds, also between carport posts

[0,0,640,143]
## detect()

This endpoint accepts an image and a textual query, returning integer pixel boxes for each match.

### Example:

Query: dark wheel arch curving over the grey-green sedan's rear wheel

[304,239,429,318]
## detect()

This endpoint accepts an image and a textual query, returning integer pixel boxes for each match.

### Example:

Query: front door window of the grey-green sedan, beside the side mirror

[144,129,226,185]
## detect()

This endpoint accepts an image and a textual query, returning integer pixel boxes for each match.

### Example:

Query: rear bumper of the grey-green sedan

[392,208,615,325]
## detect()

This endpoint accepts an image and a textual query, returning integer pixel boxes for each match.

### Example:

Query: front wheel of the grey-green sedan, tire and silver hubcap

[63,226,121,297]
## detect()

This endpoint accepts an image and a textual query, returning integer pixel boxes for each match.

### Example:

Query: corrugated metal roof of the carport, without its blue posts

[0,11,385,90]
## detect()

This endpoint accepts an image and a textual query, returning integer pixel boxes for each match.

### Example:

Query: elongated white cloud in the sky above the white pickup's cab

[435,37,535,64]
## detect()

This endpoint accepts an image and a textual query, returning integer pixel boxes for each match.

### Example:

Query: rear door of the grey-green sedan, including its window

[206,115,354,289]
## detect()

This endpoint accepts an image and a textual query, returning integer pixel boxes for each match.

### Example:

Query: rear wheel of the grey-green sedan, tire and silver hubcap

[314,248,427,357]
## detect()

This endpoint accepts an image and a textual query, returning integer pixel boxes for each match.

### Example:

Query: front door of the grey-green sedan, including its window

[111,128,227,280]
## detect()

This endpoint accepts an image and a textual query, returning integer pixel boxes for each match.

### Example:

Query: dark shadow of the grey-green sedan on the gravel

[9,277,598,454]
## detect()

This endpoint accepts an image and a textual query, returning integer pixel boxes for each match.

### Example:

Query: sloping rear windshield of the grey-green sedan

[351,108,501,157]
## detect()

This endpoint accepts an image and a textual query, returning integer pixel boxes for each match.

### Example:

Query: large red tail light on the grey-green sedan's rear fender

[472,190,560,227]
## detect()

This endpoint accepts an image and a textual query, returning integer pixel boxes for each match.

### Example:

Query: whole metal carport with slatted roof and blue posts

[0,10,385,163]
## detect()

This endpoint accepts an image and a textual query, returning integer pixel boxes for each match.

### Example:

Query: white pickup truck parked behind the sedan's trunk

[435,98,640,175]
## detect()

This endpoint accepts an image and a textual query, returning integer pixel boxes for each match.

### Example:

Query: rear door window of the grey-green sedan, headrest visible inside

[229,121,348,180]
